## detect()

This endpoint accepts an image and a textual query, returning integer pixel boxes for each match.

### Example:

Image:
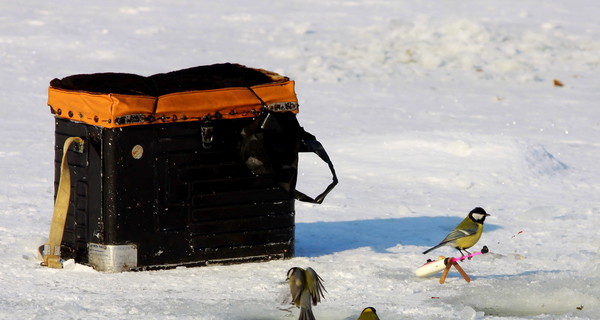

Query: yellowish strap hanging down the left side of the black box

[42,137,83,269]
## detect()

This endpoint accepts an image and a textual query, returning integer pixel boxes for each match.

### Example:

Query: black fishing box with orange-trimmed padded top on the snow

[41,64,337,271]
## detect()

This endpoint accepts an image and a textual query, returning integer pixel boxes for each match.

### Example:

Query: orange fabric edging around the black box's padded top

[48,80,298,128]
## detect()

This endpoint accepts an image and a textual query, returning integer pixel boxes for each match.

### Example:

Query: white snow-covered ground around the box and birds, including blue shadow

[0,0,600,320]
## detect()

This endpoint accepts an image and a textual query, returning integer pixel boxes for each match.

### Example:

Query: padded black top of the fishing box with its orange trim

[48,63,298,128]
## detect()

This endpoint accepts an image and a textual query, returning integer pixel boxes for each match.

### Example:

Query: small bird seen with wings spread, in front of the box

[287,267,327,320]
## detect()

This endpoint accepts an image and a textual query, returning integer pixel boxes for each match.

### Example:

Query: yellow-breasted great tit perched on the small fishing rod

[423,207,489,256]
